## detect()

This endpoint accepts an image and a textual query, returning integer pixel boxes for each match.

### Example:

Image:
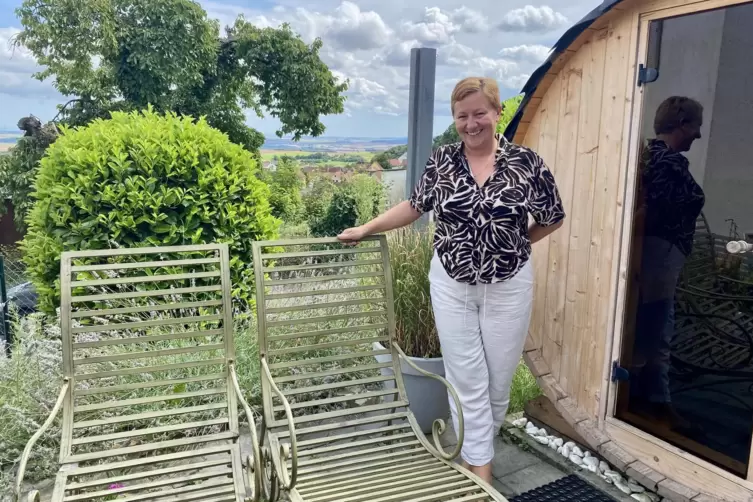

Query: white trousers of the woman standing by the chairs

[429,254,533,466]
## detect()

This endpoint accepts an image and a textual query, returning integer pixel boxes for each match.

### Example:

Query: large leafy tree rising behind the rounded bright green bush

[16,0,347,151]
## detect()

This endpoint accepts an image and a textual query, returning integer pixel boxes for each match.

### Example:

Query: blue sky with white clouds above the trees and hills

[0,0,599,137]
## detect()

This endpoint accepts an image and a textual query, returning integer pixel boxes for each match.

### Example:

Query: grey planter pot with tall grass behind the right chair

[374,342,450,434]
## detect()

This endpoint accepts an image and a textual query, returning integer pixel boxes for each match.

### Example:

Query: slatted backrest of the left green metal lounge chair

[60,244,238,463]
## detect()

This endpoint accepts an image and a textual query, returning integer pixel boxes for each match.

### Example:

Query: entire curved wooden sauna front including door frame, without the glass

[514,0,753,502]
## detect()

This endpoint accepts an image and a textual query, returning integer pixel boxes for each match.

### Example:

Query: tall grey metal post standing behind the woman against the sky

[405,47,437,228]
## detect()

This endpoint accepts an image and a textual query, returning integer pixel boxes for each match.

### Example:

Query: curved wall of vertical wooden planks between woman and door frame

[515,7,634,418]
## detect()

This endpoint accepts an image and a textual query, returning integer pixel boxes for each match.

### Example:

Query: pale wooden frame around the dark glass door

[598,0,753,492]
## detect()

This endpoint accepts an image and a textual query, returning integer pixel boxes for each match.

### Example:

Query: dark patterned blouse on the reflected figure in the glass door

[640,139,706,256]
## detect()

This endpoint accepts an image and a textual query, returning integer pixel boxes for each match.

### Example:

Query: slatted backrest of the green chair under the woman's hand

[253,236,408,427]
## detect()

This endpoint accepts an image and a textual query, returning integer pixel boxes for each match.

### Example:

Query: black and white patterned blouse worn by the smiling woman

[410,135,565,285]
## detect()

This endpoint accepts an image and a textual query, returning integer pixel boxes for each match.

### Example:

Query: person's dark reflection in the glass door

[631,96,705,428]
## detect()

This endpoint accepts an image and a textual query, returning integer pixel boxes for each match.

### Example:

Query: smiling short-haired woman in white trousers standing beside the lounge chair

[338,77,565,482]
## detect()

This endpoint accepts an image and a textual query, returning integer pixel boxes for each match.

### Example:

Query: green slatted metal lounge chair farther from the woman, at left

[16,245,261,502]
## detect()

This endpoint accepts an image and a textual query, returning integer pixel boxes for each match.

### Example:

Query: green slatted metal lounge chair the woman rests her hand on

[253,236,505,502]
